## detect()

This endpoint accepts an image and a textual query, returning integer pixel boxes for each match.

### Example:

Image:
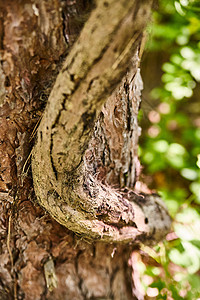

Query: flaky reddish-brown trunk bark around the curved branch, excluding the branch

[0,0,170,300]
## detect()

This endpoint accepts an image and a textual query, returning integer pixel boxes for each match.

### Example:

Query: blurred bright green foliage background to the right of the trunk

[138,0,200,300]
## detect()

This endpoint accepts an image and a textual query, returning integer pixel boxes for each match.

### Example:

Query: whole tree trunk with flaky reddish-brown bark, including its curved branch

[0,0,170,300]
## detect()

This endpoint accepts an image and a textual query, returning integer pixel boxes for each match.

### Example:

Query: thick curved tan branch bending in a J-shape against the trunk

[32,0,170,242]
